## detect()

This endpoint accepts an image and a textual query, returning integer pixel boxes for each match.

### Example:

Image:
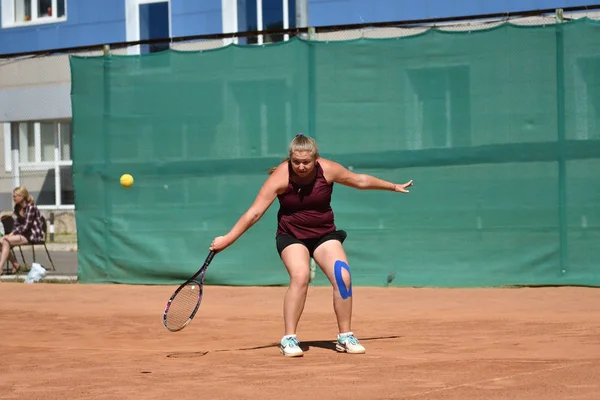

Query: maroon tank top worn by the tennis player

[277,162,336,239]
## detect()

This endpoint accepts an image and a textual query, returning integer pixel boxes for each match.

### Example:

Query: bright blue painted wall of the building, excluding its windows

[0,0,589,54]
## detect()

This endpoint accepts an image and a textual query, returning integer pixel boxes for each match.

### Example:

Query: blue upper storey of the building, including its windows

[0,0,590,55]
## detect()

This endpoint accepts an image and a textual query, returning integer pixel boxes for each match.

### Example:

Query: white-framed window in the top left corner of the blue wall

[1,0,67,27]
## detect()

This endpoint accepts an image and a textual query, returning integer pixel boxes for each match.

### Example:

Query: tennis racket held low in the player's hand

[163,251,215,332]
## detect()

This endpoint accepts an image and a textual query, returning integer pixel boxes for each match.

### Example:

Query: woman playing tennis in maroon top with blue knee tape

[210,134,412,357]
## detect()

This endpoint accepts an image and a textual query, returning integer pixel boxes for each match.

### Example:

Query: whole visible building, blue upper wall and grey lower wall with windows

[0,0,586,210]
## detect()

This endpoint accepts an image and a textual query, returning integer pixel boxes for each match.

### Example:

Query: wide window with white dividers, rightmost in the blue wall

[237,0,296,44]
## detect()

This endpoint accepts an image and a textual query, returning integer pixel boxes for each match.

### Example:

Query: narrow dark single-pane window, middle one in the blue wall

[140,1,170,54]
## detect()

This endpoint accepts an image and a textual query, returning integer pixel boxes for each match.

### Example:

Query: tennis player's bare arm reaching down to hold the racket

[210,164,288,251]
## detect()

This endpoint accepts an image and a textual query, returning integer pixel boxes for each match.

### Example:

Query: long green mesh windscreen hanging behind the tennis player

[71,19,600,287]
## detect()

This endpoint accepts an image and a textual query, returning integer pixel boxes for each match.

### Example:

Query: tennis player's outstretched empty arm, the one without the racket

[321,160,413,193]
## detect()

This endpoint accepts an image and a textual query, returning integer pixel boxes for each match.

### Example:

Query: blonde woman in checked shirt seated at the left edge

[0,186,44,274]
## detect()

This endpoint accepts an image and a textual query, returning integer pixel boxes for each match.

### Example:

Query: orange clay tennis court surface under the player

[0,283,600,400]
